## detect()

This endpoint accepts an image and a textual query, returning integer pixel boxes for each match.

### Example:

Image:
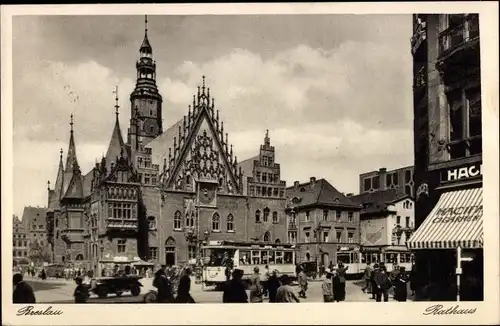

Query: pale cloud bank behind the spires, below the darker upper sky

[14,41,412,216]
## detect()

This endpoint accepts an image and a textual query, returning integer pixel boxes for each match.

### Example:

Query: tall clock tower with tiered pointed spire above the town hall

[128,16,163,152]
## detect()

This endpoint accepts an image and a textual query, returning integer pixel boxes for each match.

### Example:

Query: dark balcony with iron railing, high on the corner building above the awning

[436,15,479,79]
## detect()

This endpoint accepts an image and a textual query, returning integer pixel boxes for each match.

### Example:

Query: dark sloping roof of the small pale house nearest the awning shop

[349,189,409,214]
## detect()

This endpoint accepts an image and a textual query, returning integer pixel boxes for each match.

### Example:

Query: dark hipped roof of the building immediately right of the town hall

[286,179,360,208]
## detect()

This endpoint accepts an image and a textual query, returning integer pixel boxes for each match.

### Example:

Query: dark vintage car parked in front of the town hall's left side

[90,275,142,299]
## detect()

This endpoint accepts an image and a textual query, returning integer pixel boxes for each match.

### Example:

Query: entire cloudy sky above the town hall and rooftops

[13,14,413,216]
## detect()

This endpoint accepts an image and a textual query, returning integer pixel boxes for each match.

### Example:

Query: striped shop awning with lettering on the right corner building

[407,188,483,250]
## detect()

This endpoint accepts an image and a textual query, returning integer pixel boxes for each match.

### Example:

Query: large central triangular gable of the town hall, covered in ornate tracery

[160,77,243,194]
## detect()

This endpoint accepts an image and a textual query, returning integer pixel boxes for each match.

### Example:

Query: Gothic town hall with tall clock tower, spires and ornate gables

[47,20,287,274]
